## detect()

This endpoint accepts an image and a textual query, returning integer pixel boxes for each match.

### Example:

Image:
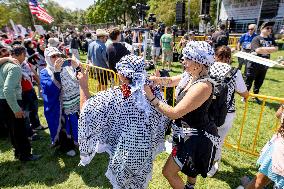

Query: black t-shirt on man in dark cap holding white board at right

[251,36,276,59]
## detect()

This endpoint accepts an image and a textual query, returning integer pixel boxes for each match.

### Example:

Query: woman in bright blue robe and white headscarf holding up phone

[40,47,80,156]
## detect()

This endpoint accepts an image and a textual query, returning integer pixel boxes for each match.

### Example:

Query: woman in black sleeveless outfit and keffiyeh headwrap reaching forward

[145,41,220,189]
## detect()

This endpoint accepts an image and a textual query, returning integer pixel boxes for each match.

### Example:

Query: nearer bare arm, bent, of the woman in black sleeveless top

[145,82,212,120]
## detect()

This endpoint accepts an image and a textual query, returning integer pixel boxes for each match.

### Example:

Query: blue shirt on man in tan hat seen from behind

[88,40,108,68]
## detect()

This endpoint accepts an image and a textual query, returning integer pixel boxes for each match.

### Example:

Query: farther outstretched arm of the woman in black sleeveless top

[149,75,182,87]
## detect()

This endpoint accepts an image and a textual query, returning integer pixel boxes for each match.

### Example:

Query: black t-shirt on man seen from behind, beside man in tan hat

[107,43,130,72]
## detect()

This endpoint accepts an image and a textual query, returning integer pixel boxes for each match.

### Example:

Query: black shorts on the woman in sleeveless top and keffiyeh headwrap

[172,129,216,178]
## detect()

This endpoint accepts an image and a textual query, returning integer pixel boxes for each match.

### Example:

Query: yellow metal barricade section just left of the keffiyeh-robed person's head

[82,64,119,94]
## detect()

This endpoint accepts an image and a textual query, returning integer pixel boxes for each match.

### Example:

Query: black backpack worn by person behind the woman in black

[209,68,238,127]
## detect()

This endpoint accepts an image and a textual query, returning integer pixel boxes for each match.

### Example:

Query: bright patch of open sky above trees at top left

[54,0,94,10]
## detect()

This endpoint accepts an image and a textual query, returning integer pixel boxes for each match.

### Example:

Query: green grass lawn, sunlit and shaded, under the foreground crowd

[0,51,284,189]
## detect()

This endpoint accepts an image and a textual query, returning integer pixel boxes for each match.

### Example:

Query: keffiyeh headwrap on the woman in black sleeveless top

[182,41,214,67]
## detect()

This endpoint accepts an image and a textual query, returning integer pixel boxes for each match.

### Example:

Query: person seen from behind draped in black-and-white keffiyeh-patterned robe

[79,55,168,189]
